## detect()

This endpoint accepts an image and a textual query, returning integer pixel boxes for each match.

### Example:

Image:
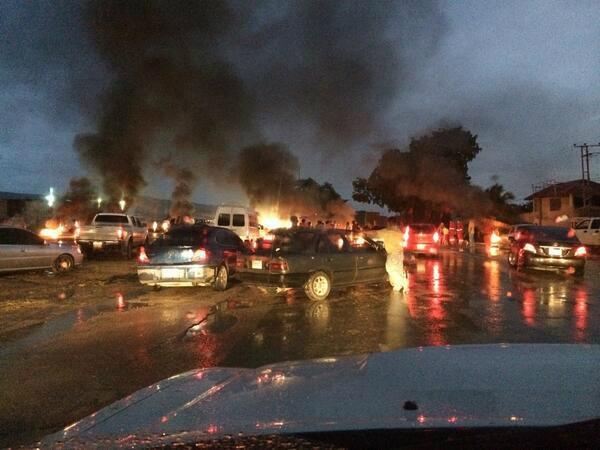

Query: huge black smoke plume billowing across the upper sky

[75,1,443,207]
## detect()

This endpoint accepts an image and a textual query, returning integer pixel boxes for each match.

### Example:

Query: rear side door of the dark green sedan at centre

[317,231,357,285]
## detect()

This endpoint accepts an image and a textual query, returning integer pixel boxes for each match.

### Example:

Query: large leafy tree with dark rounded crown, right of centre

[352,127,490,220]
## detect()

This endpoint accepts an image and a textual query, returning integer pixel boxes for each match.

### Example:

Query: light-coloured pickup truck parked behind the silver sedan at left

[76,213,148,258]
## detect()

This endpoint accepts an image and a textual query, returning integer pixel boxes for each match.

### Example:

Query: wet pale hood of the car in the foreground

[42,344,600,447]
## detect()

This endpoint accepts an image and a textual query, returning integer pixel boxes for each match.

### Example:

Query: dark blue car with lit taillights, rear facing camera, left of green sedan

[137,225,248,291]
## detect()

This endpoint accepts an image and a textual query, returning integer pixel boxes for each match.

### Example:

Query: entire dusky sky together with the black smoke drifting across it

[0,0,600,201]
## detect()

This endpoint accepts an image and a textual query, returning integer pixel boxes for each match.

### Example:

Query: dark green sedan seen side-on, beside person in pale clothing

[238,228,387,301]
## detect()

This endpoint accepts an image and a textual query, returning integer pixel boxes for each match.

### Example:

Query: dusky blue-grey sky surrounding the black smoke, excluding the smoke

[0,0,600,203]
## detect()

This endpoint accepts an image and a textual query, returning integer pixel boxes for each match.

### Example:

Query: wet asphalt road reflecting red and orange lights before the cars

[0,251,600,446]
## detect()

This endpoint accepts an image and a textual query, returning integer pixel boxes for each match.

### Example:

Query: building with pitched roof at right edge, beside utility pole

[525,180,600,225]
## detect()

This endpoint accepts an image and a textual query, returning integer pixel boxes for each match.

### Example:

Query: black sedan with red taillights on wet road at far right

[508,225,587,275]
